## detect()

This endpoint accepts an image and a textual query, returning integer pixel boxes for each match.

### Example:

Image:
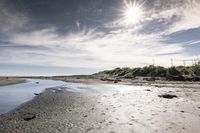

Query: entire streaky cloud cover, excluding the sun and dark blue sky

[0,0,200,72]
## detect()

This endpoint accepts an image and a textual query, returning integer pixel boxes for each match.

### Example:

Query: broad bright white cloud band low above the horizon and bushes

[1,25,190,68]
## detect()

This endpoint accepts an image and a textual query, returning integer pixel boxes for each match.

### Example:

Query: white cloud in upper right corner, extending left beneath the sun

[105,0,200,35]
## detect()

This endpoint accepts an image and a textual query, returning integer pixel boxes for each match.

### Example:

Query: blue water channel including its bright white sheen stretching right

[0,79,152,114]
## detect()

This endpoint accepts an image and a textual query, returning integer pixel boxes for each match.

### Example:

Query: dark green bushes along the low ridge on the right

[101,63,200,80]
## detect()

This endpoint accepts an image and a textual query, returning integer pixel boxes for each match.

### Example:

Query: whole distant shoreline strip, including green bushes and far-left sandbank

[0,64,200,86]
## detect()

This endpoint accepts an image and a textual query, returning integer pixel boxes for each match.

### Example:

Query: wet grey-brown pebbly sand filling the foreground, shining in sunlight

[0,80,200,133]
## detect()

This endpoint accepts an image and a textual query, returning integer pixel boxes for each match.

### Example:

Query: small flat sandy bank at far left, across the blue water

[0,77,26,86]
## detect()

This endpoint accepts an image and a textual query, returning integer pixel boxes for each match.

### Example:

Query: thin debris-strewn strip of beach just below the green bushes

[49,75,200,88]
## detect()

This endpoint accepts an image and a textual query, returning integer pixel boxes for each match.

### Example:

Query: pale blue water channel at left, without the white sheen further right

[0,79,65,114]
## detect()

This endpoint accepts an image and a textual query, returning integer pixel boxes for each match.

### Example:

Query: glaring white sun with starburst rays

[122,1,144,25]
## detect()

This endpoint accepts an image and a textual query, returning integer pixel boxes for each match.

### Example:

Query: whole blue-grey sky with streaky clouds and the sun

[0,0,200,75]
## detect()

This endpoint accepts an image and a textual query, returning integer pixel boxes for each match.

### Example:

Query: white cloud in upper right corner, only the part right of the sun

[141,0,200,35]
